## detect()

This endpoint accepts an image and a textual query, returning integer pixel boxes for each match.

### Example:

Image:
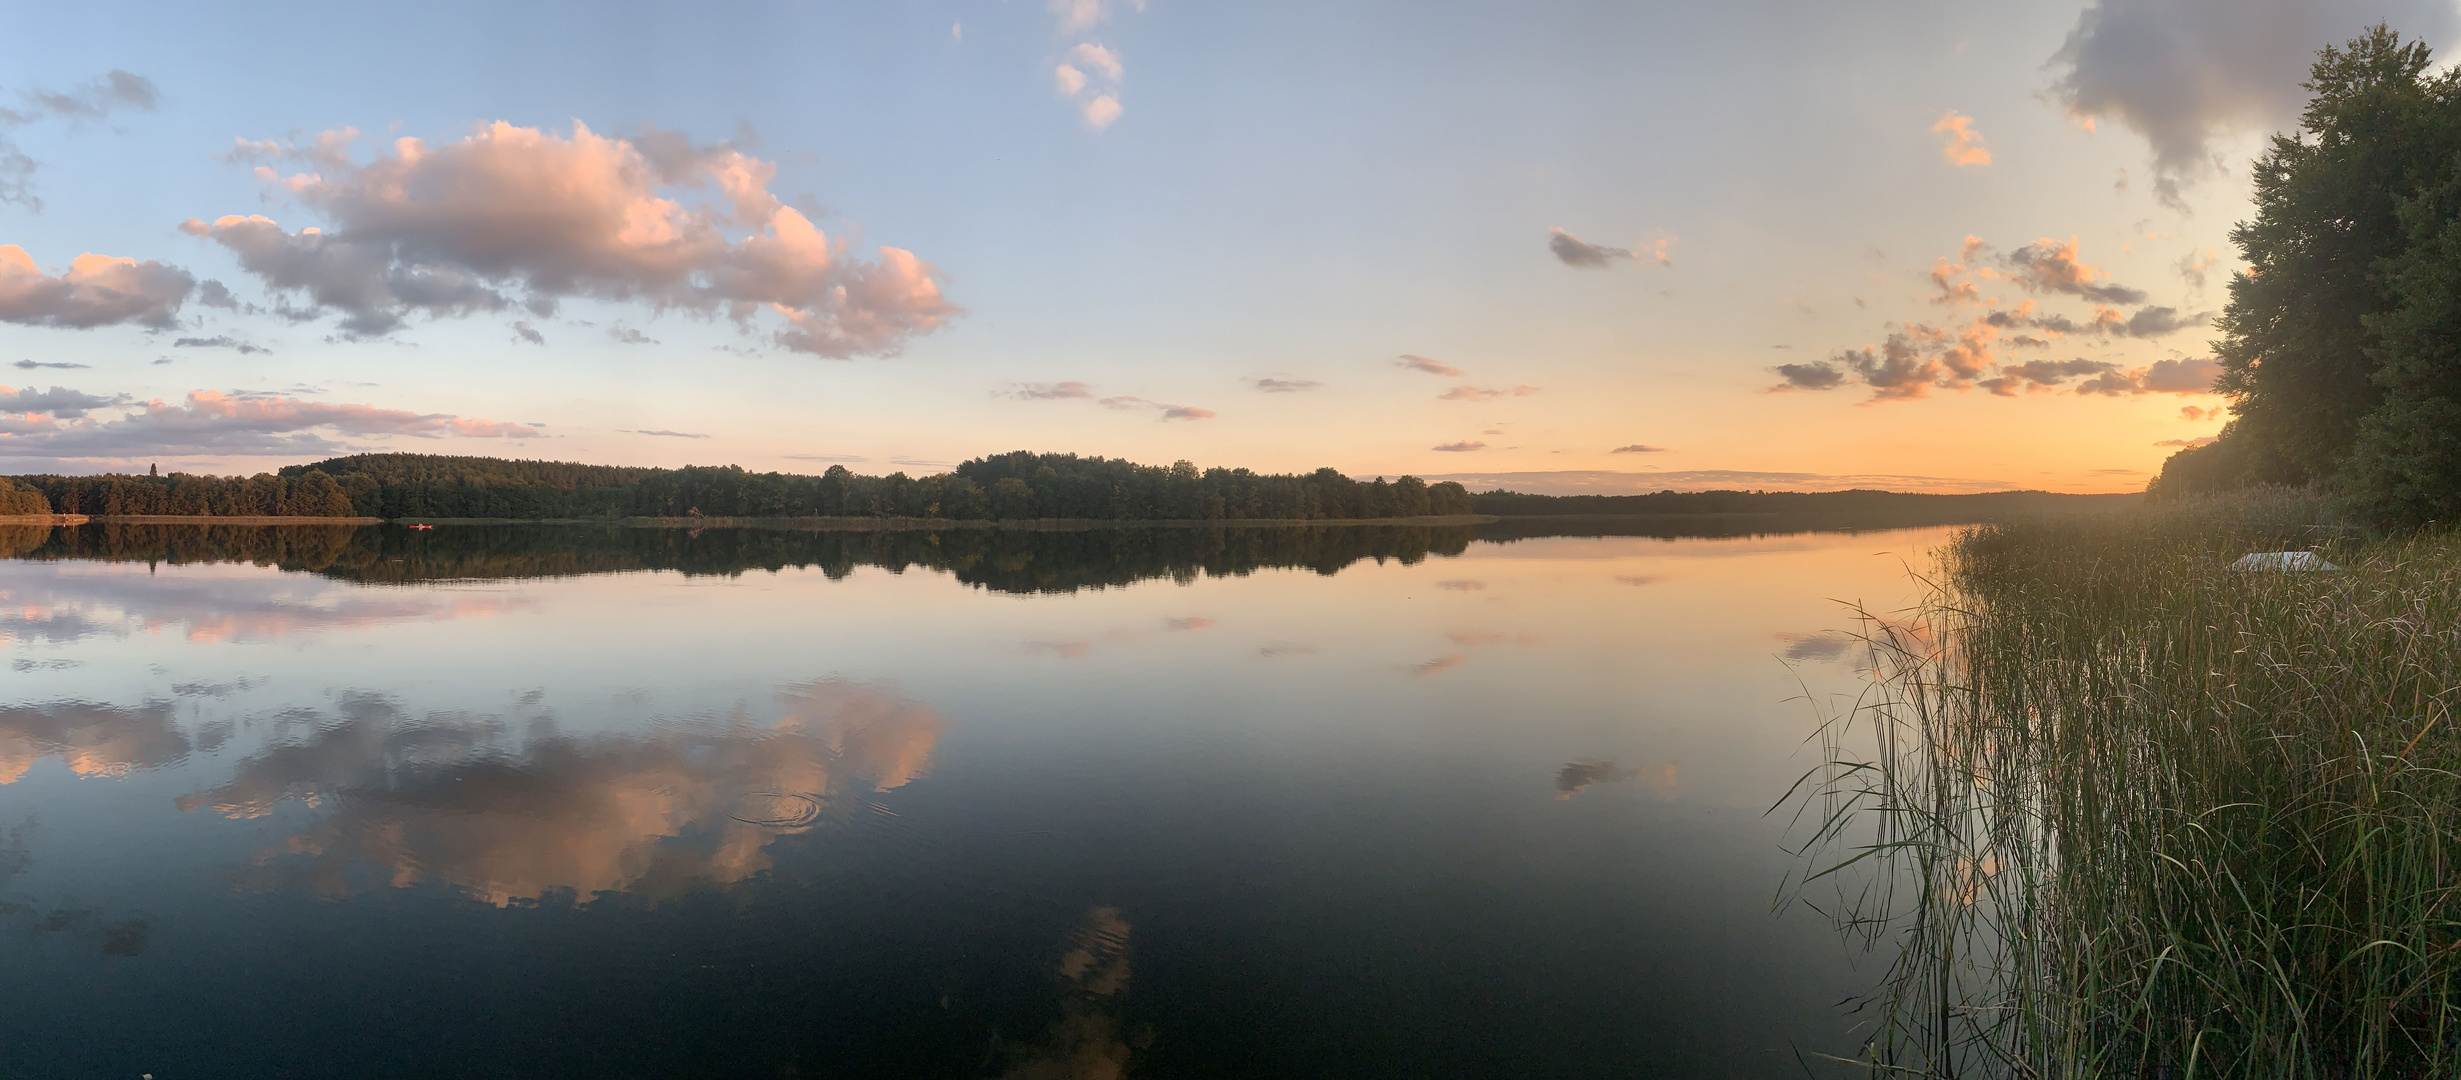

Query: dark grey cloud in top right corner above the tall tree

[2050,0,2461,207]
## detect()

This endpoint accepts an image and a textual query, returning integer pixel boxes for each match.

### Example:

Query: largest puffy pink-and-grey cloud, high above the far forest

[182,123,957,359]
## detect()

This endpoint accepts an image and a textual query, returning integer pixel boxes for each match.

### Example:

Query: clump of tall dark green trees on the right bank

[2151,25,2461,529]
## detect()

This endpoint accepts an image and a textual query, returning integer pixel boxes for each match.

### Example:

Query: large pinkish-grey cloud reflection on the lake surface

[180,679,943,903]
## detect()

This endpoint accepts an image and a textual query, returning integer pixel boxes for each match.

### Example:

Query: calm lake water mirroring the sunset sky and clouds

[0,526,1947,1080]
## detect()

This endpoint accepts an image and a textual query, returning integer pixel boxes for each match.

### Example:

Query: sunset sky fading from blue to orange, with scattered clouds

[0,0,2461,492]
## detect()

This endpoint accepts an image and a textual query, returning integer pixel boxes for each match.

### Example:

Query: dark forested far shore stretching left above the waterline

[0,450,1472,522]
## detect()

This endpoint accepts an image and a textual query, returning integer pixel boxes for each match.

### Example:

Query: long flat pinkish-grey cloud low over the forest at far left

[0,389,544,460]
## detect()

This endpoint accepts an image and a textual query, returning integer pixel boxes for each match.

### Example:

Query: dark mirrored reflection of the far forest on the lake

[25,524,1472,593]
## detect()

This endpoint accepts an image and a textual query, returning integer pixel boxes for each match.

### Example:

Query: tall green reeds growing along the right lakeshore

[1794,492,2461,1078]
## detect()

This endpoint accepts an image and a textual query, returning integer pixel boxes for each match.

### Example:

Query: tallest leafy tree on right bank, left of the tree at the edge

[2195,25,2461,487]
